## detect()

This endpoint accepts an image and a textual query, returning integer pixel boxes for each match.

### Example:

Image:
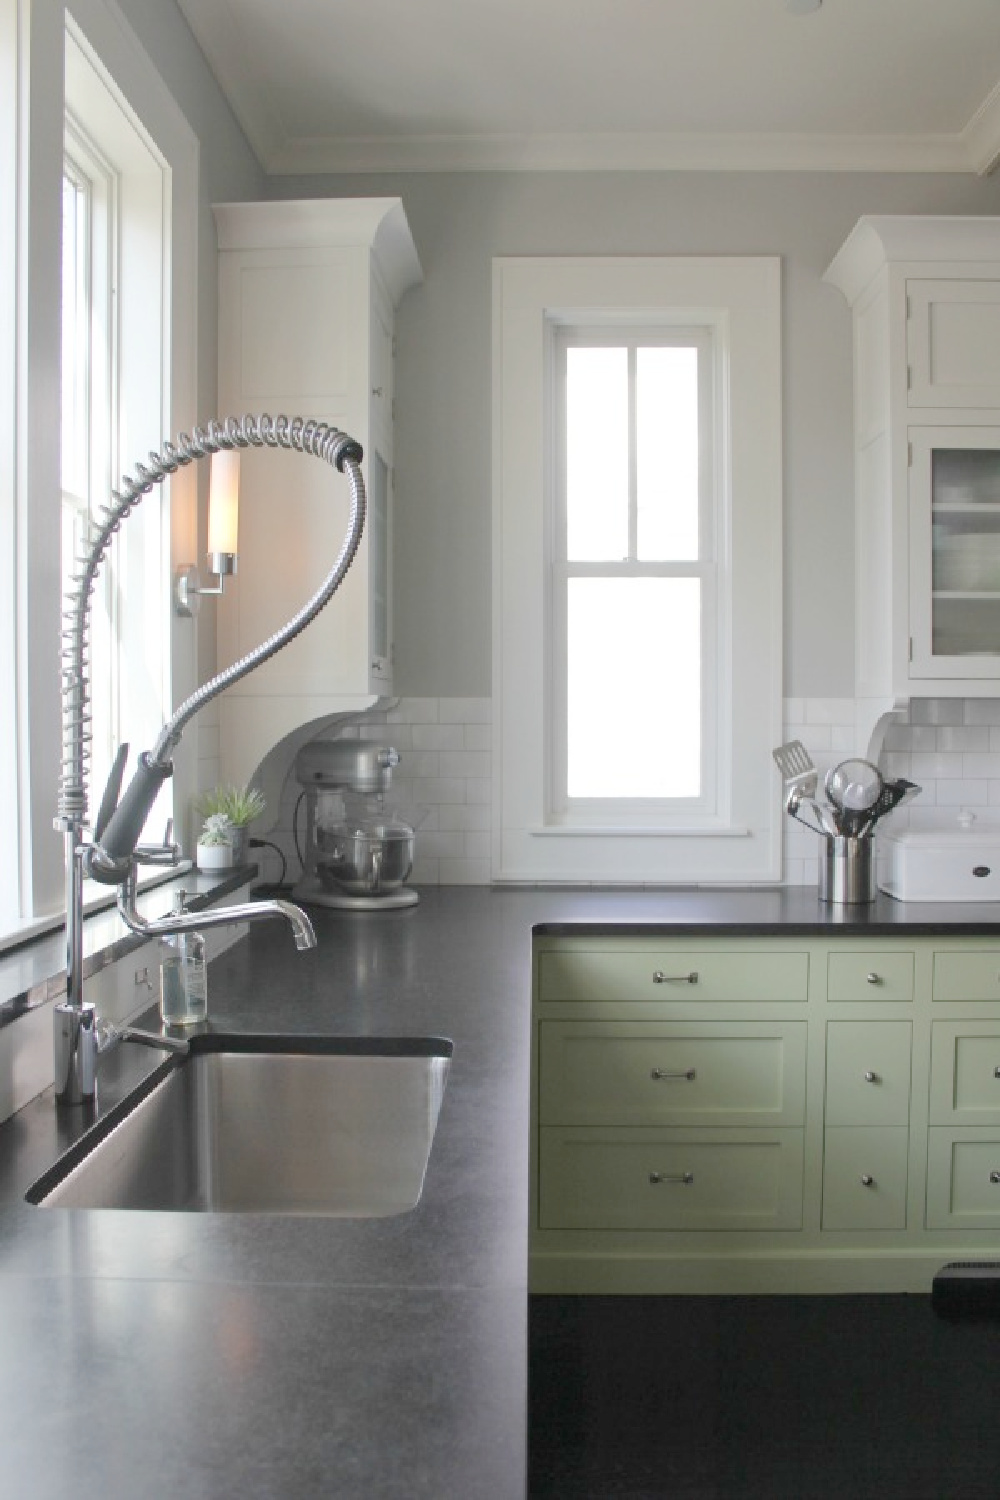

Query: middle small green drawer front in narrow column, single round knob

[826,1022,912,1125]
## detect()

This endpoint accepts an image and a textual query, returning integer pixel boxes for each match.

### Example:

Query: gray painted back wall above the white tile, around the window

[269,168,1000,698]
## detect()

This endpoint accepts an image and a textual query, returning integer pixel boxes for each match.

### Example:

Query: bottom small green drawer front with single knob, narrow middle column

[823,1125,910,1230]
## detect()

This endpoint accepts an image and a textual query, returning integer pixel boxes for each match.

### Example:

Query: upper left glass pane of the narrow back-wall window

[567,348,628,563]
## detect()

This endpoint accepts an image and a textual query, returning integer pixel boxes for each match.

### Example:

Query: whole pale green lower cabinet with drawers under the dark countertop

[531,930,1000,1295]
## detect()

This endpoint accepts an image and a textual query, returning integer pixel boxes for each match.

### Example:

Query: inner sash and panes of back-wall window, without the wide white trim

[549,329,720,824]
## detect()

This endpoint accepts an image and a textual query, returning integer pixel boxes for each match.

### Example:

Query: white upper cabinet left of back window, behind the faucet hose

[214,198,423,783]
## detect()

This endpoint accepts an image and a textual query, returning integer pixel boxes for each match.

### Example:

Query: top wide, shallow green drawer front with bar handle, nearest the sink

[538,948,810,1004]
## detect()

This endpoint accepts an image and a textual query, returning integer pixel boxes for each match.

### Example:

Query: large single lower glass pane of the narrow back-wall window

[567,578,702,798]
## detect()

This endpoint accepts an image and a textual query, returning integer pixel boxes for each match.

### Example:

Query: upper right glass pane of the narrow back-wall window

[636,348,699,563]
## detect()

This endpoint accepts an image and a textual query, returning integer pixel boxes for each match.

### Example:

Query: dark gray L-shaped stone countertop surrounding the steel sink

[0,888,1000,1500]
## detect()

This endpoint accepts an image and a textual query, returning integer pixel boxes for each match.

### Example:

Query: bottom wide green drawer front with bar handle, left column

[538,1128,802,1230]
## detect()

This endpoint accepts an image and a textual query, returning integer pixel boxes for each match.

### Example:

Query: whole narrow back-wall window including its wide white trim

[493,257,781,885]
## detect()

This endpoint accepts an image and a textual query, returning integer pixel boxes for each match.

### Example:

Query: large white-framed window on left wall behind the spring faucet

[0,0,198,948]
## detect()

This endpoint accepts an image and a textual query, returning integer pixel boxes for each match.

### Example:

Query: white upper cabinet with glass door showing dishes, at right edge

[825,216,1000,716]
